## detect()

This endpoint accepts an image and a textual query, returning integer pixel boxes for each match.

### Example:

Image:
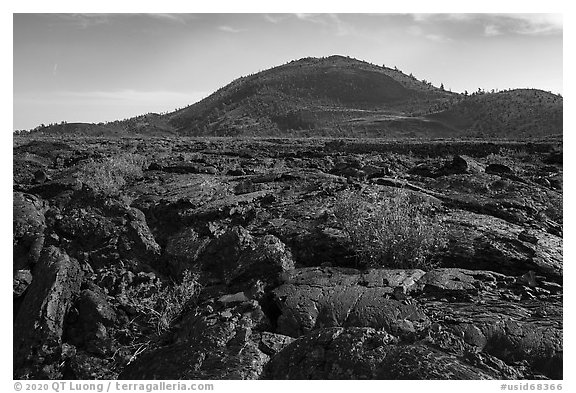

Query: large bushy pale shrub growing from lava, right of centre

[334,190,446,269]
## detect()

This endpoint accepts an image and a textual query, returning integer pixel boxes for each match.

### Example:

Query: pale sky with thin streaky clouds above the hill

[13,13,563,130]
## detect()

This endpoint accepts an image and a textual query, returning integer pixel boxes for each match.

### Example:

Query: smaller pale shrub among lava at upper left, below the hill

[78,153,146,195]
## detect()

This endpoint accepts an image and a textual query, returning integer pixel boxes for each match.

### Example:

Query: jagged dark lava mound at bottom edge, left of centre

[119,303,270,379]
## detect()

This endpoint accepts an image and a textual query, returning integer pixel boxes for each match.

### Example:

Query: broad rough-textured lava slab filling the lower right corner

[412,268,562,379]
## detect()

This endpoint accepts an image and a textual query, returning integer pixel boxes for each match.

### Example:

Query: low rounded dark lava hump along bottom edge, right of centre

[263,327,519,380]
